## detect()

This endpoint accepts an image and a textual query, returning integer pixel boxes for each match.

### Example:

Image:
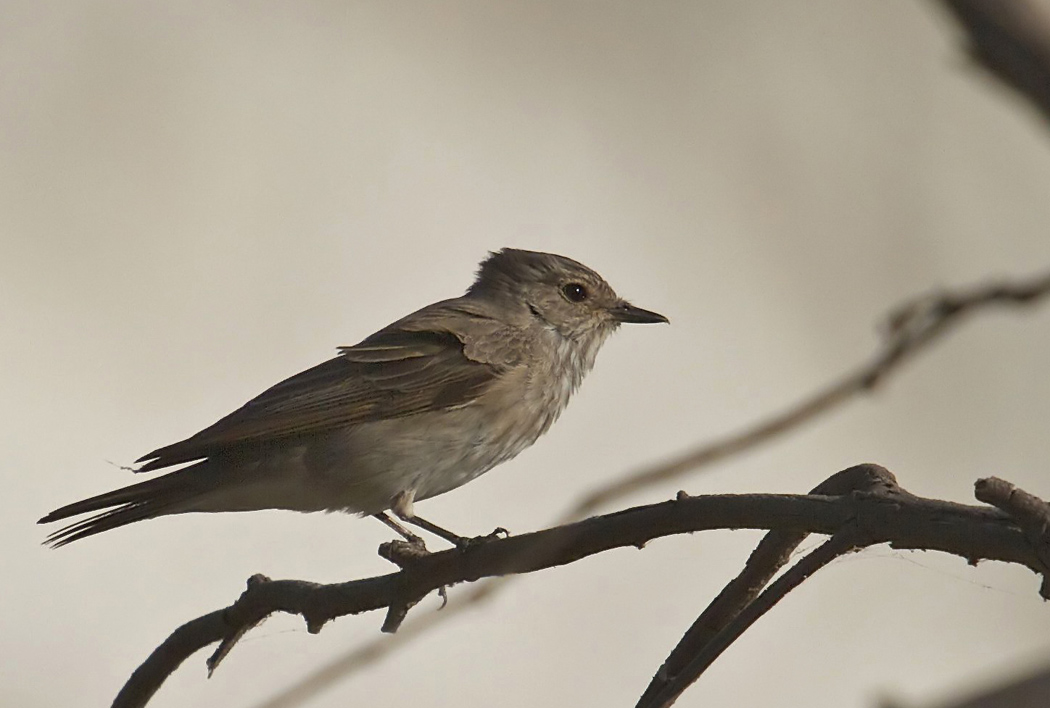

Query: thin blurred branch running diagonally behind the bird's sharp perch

[256,271,1050,708]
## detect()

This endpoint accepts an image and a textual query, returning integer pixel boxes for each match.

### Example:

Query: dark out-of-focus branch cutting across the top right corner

[942,0,1050,125]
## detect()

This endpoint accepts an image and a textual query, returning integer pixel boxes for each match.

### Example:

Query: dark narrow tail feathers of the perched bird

[37,462,213,548]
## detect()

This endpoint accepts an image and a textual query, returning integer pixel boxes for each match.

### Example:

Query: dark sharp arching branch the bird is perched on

[113,465,1044,708]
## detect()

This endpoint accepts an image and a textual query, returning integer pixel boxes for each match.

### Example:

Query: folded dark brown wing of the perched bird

[139,311,509,472]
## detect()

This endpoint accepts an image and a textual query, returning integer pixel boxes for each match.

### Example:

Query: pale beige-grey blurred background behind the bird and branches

[0,0,1050,708]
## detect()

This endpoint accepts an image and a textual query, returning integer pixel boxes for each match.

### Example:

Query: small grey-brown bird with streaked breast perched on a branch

[39,248,669,547]
